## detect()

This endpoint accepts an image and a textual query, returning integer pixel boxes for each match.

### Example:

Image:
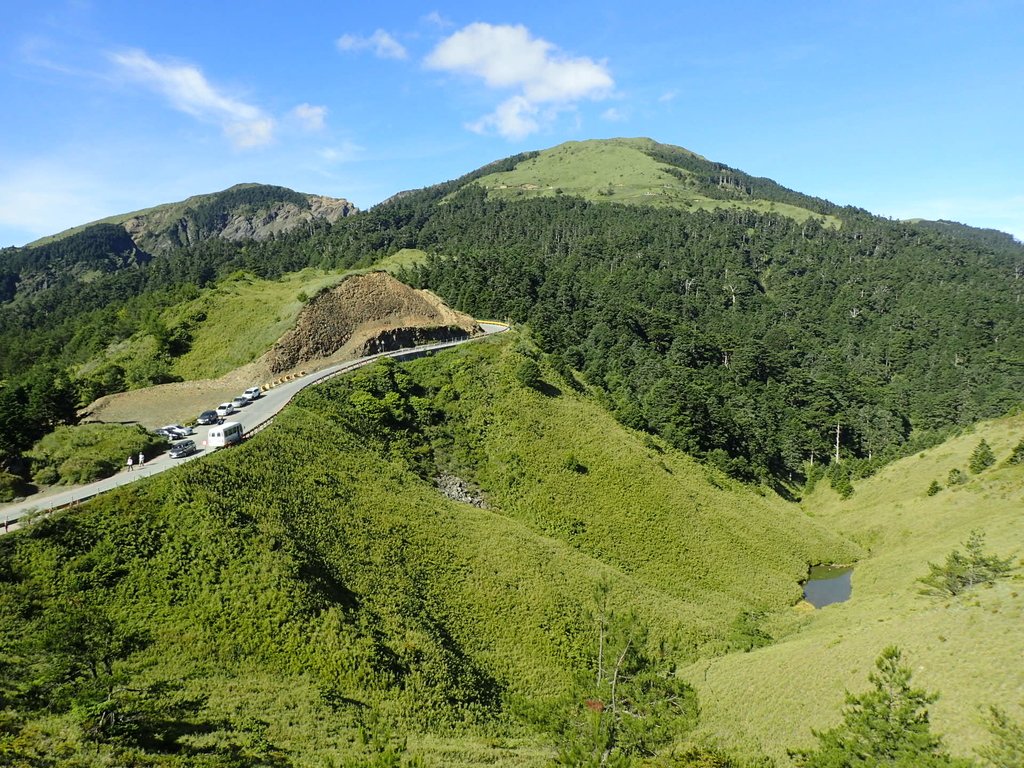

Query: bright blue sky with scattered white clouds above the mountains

[0,0,1024,245]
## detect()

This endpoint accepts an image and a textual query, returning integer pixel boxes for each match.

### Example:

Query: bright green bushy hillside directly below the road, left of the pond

[0,338,856,766]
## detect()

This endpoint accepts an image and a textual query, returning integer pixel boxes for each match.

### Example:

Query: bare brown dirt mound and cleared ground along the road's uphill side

[83,272,481,428]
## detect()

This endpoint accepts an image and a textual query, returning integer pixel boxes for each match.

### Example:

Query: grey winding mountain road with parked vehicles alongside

[0,323,509,534]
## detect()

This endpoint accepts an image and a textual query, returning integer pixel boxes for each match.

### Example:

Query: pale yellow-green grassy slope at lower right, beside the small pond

[688,416,1024,758]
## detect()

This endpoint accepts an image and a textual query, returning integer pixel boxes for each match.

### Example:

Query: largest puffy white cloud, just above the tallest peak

[425,22,614,139]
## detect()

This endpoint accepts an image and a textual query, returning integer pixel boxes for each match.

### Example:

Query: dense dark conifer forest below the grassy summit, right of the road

[411,187,1024,477]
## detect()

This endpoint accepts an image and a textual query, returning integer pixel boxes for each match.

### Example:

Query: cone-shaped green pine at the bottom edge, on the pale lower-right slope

[791,645,959,768]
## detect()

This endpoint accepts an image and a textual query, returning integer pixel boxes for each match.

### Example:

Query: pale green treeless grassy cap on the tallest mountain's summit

[475,138,839,226]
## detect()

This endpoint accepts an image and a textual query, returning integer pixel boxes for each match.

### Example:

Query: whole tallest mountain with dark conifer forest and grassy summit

[0,139,1024,493]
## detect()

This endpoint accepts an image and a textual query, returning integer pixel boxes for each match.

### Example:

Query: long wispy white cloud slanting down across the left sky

[110,50,274,147]
